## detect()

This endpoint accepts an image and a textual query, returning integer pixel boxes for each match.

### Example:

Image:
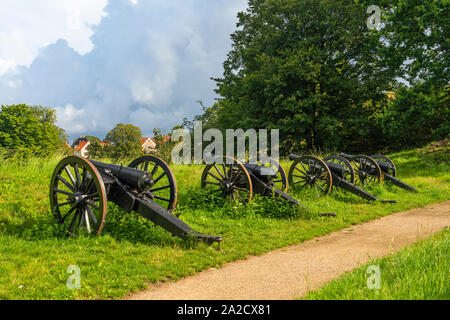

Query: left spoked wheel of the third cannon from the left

[288,156,333,196]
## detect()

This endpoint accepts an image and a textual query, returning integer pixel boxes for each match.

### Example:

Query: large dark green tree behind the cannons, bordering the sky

[212,0,393,150]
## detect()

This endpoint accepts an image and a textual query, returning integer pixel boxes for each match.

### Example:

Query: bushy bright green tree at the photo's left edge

[0,104,65,157]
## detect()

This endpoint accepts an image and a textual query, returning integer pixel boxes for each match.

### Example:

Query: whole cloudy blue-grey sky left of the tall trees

[0,0,247,140]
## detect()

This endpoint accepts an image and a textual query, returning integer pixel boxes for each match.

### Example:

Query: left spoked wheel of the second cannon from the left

[201,156,253,203]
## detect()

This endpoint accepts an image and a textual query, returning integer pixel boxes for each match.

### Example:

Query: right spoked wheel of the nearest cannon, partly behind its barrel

[128,156,178,212]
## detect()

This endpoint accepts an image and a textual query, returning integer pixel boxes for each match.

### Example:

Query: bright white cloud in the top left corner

[0,0,107,66]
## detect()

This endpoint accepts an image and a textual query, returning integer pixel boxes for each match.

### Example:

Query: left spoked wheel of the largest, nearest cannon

[50,156,107,236]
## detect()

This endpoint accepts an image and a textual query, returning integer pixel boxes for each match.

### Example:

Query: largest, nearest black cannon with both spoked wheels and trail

[50,156,222,246]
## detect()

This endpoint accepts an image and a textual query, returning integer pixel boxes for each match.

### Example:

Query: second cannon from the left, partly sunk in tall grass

[201,155,309,210]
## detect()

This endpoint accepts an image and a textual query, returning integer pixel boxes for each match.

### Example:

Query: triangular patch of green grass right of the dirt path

[304,229,450,300]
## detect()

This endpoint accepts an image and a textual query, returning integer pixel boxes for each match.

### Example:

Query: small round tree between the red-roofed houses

[104,123,142,160]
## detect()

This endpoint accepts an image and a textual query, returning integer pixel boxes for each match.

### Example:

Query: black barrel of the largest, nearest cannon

[89,160,151,190]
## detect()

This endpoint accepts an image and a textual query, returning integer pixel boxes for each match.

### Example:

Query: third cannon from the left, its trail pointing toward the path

[288,154,396,203]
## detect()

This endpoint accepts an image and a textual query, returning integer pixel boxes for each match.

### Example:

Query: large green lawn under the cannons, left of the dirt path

[0,146,450,299]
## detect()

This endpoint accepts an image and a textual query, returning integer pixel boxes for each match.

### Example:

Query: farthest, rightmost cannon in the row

[339,153,417,192]
